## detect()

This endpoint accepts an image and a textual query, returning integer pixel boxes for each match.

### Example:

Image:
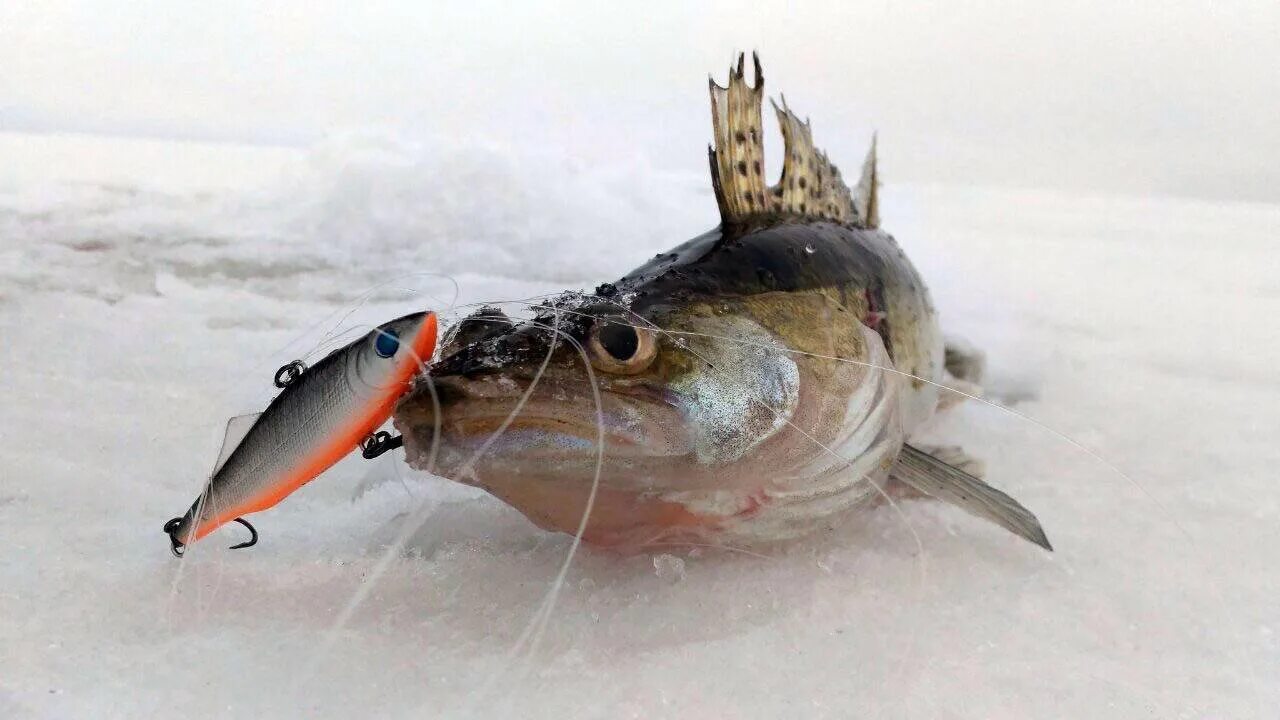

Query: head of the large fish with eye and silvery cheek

[396,286,890,543]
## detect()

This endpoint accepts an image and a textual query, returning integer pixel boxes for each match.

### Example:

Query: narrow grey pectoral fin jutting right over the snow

[890,445,1053,551]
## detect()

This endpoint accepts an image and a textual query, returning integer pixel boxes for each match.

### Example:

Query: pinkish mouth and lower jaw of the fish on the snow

[396,375,747,550]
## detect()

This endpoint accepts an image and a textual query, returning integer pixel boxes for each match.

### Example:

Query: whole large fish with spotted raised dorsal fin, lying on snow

[393,54,1052,550]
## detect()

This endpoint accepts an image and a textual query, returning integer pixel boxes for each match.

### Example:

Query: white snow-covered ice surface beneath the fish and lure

[0,135,1280,719]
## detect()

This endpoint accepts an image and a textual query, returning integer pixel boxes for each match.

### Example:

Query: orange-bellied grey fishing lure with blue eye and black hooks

[164,311,438,557]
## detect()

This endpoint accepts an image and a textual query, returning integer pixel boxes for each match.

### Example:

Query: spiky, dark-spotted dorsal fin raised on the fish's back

[710,54,878,227]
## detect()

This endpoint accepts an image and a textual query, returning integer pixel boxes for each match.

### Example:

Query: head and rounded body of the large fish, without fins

[398,222,942,546]
